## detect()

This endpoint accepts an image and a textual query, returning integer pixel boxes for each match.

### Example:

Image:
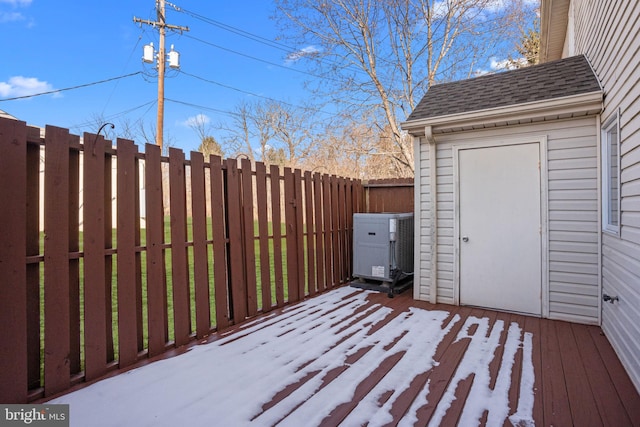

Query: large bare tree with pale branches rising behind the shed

[276,0,530,172]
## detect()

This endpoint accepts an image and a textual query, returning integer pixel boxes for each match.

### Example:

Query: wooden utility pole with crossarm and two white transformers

[133,0,189,152]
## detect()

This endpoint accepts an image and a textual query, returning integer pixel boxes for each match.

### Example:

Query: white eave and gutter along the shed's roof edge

[401,91,603,136]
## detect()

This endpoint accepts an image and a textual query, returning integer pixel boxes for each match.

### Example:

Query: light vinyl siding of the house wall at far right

[565,0,640,390]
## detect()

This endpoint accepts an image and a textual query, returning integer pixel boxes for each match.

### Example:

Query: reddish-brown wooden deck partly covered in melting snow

[51,287,640,427]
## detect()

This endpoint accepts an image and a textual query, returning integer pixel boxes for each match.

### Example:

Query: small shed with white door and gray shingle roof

[402,55,603,324]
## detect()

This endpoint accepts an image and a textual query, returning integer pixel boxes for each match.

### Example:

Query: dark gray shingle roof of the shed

[407,55,601,122]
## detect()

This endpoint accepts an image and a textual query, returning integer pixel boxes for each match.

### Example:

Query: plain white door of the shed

[458,143,542,315]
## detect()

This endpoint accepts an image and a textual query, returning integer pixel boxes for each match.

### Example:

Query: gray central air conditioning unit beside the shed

[352,213,413,296]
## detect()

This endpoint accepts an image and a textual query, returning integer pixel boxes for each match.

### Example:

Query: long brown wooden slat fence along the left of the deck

[0,119,363,403]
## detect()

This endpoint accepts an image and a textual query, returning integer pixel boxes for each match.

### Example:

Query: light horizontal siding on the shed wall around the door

[419,116,600,324]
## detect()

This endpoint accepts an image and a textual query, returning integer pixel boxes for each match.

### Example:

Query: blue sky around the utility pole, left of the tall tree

[0,0,309,151]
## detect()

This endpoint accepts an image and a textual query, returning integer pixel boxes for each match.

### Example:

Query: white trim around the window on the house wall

[600,109,622,235]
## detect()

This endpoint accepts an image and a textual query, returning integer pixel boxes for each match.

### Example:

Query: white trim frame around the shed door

[451,135,549,318]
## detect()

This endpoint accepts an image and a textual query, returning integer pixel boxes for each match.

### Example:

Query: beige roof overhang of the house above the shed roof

[539,0,571,62]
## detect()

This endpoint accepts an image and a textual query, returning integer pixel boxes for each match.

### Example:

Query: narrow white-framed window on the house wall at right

[602,112,620,234]
